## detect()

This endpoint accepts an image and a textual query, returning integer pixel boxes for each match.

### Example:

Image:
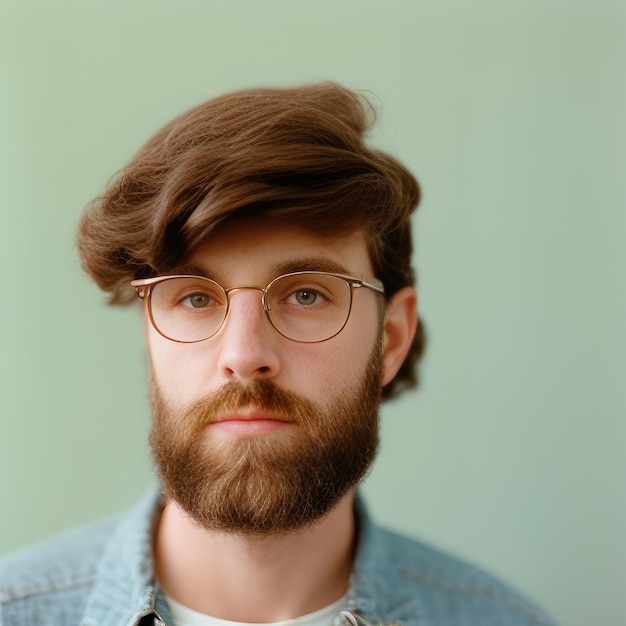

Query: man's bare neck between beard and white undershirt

[154,493,355,623]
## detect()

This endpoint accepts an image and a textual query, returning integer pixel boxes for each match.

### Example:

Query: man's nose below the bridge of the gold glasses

[214,289,280,382]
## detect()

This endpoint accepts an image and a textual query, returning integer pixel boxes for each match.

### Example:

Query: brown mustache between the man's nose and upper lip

[180,380,317,429]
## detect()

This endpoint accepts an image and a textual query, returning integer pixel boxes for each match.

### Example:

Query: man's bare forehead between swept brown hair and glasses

[184,217,372,280]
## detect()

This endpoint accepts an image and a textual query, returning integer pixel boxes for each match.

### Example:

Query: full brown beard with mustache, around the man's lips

[150,343,382,537]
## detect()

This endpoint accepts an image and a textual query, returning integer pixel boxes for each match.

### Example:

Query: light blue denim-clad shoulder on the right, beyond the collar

[358,504,555,626]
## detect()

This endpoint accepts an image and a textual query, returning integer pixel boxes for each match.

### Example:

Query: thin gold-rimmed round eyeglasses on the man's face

[130,272,385,343]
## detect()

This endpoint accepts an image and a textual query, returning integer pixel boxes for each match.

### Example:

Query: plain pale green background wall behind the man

[0,0,626,626]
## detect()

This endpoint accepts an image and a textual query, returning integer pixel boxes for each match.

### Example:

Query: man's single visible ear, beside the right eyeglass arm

[382,287,417,386]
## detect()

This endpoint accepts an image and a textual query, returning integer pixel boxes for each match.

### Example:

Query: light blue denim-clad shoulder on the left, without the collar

[0,519,116,626]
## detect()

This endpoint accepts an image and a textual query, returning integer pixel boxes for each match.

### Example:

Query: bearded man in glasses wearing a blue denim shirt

[0,84,551,626]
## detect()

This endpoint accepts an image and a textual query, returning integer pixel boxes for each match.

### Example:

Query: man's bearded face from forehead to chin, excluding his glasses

[147,219,388,535]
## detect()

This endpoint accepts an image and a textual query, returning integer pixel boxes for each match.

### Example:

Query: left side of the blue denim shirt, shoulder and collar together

[0,486,161,626]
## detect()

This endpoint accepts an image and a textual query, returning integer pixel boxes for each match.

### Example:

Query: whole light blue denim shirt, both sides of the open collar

[0,489,554,626]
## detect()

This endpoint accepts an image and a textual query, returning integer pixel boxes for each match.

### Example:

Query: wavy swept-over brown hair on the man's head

[78,83,424,397]
